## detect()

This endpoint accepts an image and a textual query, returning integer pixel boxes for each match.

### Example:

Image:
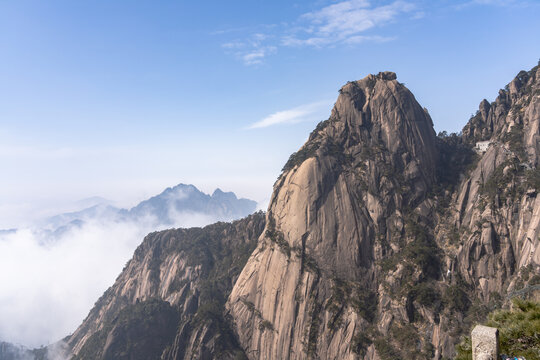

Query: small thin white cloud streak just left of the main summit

[248,101,332,129]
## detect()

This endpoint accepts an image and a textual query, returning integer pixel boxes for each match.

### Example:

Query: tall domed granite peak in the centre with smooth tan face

[227,73,439,359]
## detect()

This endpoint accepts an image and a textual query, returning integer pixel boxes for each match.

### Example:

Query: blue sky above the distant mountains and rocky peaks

[0,0,540,227]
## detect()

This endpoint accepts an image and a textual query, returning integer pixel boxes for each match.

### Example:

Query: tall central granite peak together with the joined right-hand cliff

[227,68,540,359]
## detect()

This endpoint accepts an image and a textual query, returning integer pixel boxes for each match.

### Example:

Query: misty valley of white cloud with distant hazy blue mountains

[0,185,256,348]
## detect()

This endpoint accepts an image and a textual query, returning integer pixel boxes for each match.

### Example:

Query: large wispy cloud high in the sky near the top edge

[216,0,418,65]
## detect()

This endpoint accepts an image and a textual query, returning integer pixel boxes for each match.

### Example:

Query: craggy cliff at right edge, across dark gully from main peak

[448,66,540,302]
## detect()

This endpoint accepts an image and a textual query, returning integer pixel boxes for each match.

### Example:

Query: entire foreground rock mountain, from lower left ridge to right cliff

[27,63,540,360]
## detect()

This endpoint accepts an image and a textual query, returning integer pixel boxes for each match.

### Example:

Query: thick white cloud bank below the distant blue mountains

[0,209,224,347]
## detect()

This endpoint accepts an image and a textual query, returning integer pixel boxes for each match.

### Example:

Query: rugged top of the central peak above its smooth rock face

[284,71,437,187]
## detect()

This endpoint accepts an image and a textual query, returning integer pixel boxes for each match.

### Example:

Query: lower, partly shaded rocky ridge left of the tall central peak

[67,213,265,360]
